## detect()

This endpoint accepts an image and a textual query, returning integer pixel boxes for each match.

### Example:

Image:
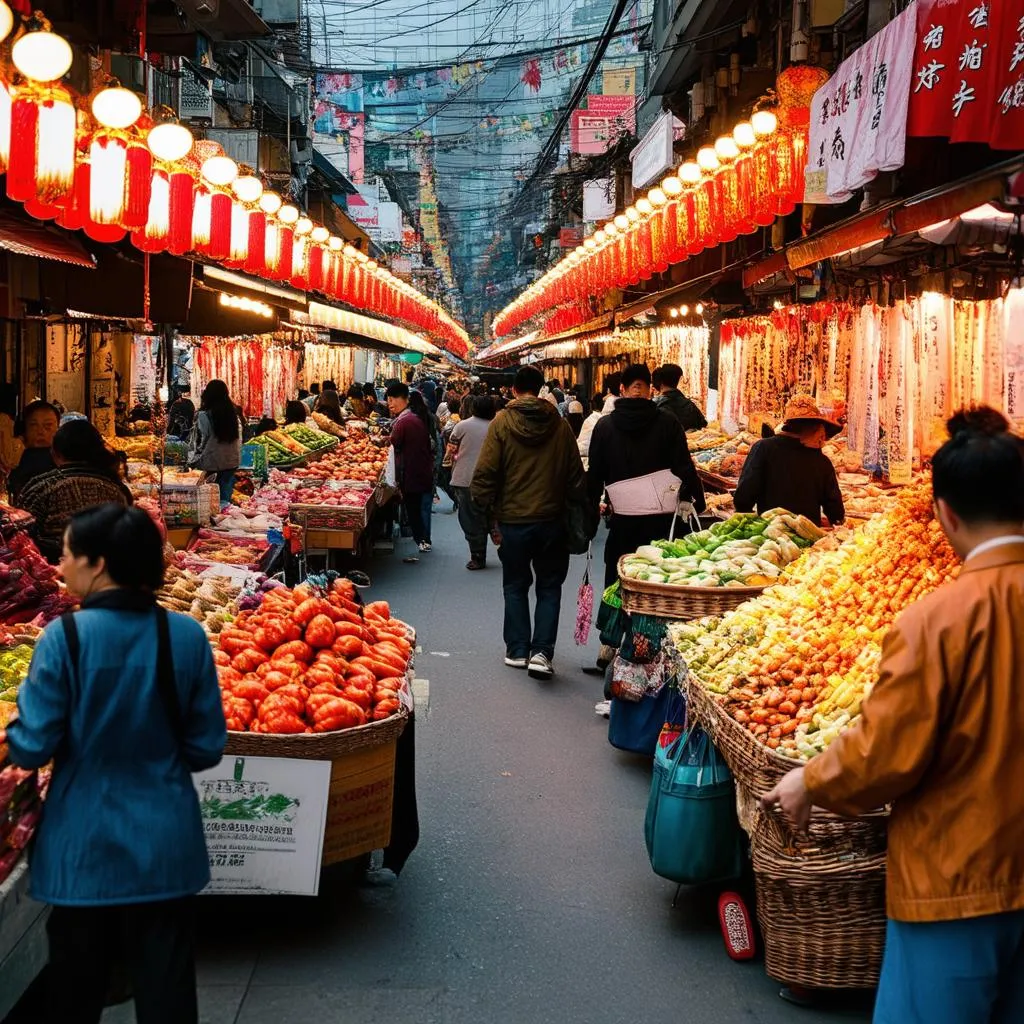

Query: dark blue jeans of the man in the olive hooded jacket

[498,519,569,657]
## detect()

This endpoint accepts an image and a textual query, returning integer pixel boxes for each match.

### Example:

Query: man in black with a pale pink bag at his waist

[587,364,706,587]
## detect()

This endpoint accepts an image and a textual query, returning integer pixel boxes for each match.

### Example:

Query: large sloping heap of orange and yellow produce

[670,485,957,760]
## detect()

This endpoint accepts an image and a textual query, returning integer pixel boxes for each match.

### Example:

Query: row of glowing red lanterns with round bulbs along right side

[494,111,807,337]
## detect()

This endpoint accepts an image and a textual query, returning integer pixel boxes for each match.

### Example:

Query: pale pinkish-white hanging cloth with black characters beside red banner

[806,4,916,203]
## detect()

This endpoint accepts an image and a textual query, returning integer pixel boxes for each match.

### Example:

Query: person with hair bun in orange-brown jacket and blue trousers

[763,409,1024,1024]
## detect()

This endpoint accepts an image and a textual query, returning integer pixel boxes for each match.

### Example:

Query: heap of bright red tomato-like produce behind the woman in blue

[214,580,413,733]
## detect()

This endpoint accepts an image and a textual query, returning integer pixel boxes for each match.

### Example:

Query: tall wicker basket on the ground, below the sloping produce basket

[754,844,886,988]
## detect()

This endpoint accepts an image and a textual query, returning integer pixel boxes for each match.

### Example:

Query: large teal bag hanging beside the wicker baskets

[644,727,743,885]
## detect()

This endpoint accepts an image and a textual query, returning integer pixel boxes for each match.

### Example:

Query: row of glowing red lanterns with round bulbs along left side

[0,2,468,354]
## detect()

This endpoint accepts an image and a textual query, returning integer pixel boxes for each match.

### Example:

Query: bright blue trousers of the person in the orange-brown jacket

[873,910,1024,1024]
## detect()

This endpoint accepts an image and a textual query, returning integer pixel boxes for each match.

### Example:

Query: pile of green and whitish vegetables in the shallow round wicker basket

[622,509,824,587]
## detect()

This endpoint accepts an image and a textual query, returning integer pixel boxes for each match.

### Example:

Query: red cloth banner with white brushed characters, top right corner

[907,0,1024,150]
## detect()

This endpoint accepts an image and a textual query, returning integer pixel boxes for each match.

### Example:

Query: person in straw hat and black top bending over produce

[734,394,846,526]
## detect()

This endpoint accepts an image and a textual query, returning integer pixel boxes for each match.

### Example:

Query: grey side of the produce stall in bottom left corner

[0,856,50,1019]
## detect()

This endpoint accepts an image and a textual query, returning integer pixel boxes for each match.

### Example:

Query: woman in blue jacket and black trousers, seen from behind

[7,505,226,1024]
